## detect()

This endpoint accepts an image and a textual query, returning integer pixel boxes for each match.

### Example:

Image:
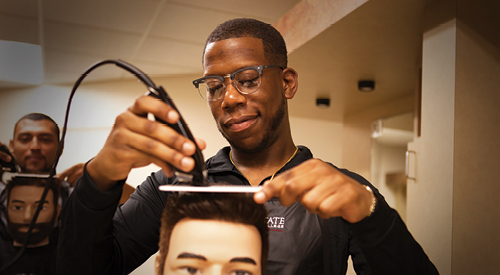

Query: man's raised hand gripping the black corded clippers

[87,96,205,191]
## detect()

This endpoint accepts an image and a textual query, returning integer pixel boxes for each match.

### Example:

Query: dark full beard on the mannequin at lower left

[7,222,54,245]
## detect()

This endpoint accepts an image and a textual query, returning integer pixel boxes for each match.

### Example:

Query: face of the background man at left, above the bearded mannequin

[10,119,58,173]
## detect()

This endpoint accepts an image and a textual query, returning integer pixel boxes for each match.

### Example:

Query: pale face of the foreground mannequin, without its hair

[159,218,262,275]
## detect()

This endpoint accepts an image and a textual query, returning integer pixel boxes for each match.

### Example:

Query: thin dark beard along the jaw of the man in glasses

[221,97,286,154]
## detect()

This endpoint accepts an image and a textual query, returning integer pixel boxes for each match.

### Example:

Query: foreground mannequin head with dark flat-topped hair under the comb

[155,193,268,275]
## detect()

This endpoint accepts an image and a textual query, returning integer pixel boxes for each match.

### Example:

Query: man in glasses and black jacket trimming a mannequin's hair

[58,19,437,275]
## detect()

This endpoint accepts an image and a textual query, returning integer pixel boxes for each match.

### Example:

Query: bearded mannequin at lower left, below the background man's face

[0,176,61,275]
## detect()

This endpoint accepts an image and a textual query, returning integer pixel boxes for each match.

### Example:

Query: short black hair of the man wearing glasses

[202,18,288,68]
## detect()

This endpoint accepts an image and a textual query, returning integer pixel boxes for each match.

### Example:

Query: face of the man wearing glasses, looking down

[204,37,288,153]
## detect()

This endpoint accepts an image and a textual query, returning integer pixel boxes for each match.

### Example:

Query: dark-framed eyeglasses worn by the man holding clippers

[193,65,283,101]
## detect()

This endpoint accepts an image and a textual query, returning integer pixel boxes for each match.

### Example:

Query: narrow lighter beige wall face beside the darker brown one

[407,20,456,274]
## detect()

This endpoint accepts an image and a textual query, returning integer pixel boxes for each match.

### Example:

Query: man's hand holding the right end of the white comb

[254,159,372,223]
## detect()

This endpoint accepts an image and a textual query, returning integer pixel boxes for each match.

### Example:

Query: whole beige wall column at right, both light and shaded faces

[408,1,500,274]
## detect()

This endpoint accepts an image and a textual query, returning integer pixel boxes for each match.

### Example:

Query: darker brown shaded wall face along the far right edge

[452,17,500,274]
